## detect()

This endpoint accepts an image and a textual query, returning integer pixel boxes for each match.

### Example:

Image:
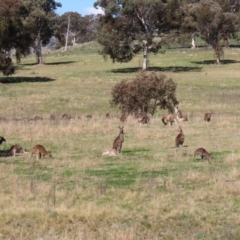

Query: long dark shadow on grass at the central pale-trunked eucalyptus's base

[111,66,202,73]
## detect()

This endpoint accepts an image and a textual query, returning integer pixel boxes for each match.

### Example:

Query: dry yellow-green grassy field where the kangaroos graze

[0,44,240,240]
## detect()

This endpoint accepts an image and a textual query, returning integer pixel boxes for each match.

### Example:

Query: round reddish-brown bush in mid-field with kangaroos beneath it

[110,71,178,115]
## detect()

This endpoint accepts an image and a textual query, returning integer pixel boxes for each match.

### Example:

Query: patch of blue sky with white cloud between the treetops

[56,0,102,16]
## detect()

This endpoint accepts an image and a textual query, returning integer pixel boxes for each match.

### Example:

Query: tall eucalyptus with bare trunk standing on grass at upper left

[22,0,62,64]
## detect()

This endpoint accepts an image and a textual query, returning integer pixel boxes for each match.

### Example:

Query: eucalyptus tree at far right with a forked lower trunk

[181,0,240,64]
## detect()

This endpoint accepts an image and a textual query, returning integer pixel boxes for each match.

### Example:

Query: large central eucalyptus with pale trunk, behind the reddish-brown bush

[94,0,179,70]
